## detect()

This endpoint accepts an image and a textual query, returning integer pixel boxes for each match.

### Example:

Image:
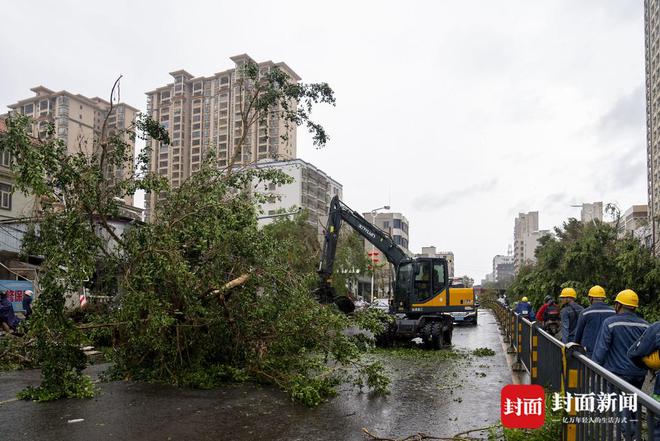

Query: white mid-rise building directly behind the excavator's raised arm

[256,159,342,239]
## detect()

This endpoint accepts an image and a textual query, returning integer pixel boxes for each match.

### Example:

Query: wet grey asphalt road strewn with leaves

[0,310,511,441]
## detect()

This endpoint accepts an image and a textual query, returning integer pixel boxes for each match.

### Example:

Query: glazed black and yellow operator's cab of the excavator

[393,257,449,314]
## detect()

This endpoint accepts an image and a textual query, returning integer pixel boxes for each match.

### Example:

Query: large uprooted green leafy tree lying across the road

[0,64,388,405]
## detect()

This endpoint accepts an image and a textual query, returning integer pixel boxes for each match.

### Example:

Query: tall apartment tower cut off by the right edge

[644,0,660,254]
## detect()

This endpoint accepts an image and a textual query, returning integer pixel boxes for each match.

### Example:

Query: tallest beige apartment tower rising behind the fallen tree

[145,54,300,218]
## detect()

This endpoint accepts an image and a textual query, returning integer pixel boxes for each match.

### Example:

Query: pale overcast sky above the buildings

[0,0,647,280]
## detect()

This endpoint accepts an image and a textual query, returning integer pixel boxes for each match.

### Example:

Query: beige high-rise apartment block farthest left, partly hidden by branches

[0,86,141,211]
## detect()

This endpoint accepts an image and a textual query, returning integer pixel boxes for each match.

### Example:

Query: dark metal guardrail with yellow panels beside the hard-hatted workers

[489,302,660,441]
